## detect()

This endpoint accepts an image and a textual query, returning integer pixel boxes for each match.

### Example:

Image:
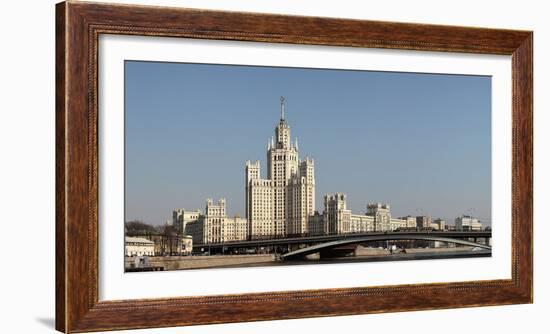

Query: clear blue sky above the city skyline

[125,61,491,225]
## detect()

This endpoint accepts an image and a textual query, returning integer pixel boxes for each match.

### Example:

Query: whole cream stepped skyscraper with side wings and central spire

[245,97,315,239]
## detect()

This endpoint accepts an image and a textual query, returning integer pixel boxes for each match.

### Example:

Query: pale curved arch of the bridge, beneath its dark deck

[280,233,491,260]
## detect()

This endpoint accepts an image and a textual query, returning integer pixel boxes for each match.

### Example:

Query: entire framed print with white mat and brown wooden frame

[56,1,533,332]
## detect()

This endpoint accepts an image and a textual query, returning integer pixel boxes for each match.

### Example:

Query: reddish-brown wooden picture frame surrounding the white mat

[56,1,533,333]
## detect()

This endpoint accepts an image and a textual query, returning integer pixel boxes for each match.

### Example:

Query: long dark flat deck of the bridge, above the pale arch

[193,231,491,253]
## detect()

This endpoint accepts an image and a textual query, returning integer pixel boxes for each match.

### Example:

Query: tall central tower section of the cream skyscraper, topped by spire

[267,96,298,235]
